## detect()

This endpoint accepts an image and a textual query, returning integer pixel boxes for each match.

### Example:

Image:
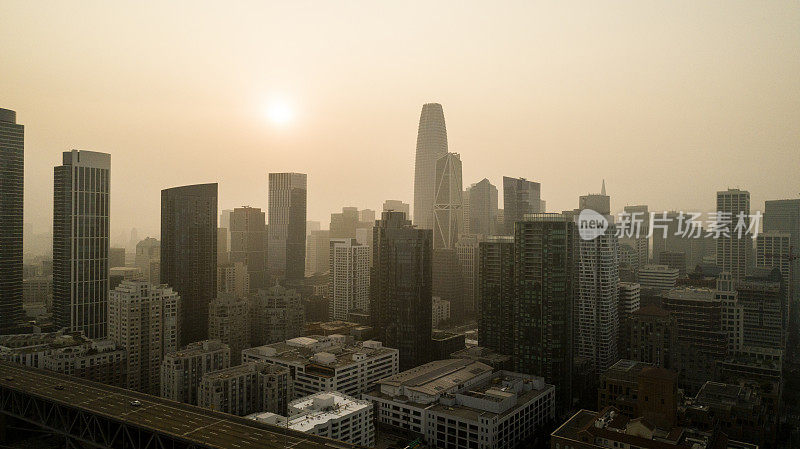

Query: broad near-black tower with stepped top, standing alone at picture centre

[370,211,433,371]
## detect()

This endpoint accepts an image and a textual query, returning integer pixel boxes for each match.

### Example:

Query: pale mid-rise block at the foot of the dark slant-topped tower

[160,340,231,405]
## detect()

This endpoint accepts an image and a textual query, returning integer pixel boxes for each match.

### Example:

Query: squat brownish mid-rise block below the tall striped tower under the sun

[250,284,305,346]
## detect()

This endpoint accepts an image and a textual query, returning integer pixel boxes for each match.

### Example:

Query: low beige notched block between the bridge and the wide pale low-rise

[197,362,293,416]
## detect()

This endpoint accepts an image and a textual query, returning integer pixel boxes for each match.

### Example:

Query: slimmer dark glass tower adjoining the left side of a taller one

[478,236,515,355]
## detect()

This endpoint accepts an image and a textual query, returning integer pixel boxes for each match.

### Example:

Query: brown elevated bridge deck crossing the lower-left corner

[0,362,358,449]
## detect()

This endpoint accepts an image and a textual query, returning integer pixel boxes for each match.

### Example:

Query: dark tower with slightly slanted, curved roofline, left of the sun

[161,183,217,346]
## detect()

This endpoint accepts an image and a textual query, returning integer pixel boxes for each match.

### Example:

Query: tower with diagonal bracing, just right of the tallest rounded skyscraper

[433,153,462,250]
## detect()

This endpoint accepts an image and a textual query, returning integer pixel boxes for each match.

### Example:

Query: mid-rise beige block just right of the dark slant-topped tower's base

[208,293,250,365]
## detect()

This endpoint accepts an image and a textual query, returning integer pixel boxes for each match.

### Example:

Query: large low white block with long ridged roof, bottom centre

[362,359,555,449]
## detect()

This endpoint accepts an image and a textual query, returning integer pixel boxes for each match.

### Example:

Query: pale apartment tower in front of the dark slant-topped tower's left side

[108,281,180,394]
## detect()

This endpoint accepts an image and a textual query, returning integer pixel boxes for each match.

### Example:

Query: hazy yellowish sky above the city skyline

[0,0,800,245]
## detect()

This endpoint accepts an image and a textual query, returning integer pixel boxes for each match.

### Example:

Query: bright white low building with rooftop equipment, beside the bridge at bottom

[248,391,375,447]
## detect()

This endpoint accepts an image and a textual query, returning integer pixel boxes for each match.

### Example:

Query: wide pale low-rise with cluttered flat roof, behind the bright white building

[242,335,399,397]
